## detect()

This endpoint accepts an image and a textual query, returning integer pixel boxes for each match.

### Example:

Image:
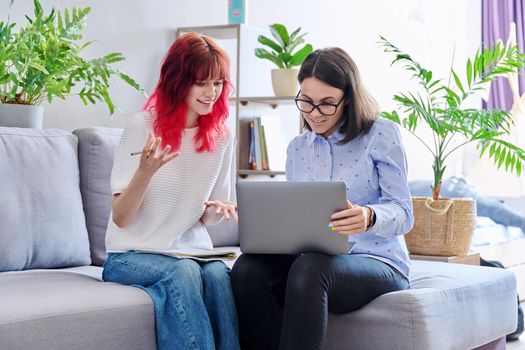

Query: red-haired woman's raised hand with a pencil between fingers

[138,132,180,177]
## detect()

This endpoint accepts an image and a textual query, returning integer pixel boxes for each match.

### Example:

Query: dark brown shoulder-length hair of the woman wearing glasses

[298,47,379,144]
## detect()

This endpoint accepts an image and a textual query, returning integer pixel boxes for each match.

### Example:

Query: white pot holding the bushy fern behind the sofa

[0,103,44,129]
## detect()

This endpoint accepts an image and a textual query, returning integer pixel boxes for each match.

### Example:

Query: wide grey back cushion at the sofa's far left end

[0,127,91,271]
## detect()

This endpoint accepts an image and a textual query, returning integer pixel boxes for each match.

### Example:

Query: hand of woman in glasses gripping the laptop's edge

[328,200,372,235]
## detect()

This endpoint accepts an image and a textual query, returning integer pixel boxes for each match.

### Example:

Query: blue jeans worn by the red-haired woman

[102,252,239,350]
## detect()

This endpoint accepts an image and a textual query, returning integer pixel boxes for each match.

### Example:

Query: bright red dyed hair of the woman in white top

[144,33,231,152]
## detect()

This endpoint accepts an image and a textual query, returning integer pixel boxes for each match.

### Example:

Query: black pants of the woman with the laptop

[232,254,409,350]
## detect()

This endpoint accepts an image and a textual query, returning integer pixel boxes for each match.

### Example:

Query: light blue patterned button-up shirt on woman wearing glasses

[286,118,414,277]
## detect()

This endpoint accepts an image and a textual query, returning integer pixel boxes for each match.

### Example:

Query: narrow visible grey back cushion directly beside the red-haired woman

[73,127,122,266]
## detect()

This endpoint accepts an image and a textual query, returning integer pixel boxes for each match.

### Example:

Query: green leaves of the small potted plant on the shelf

[255,23,313,68]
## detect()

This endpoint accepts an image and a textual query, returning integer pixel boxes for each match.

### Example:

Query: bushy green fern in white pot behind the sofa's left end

[0,0,143,127]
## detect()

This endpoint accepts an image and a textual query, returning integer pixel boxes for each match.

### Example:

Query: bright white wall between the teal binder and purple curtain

[248,0,481,179]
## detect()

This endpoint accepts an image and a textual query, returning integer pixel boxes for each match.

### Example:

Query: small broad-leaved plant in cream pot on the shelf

[255,23,313,96]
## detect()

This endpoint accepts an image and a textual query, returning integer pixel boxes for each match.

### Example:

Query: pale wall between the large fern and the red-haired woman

[0,0,227,130]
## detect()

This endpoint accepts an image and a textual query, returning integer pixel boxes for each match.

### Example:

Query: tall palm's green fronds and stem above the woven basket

[379,36,525,200]
